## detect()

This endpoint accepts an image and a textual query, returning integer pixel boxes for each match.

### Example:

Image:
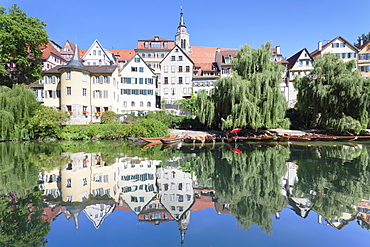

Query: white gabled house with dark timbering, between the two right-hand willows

[281,48,313,108]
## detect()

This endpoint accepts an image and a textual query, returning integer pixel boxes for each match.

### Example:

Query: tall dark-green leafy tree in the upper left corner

[0,4,48,87]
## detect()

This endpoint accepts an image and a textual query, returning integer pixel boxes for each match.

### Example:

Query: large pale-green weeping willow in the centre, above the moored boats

[197,43,290,129]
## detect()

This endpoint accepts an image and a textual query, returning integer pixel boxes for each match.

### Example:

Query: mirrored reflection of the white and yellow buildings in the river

[39,144,370,243]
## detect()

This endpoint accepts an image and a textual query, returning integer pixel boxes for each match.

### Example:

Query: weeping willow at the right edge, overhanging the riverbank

[294,54,370,133]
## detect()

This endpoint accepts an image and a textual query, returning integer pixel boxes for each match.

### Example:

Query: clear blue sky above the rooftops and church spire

[0,0,370,58]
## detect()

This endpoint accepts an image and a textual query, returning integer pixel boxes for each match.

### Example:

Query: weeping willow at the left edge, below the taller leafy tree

[0,85,39,140]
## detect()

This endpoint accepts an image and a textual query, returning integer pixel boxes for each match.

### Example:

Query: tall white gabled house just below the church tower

[159,45,194,104]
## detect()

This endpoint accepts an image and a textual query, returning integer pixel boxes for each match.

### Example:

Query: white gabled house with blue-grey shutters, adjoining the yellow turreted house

[118,54,156,115]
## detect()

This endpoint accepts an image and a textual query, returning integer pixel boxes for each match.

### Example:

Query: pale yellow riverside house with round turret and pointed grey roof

[44,45,119,124]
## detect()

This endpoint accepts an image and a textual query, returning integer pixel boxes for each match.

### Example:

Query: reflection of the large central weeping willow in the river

[197,145,290,234]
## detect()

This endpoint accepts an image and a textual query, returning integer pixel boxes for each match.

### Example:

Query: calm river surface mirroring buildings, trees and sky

[0,141,370,246]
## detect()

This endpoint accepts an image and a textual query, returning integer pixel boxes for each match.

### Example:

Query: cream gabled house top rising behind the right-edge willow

[311,36,358,62]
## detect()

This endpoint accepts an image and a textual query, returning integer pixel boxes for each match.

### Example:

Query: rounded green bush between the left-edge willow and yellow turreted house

[29,106,69,138]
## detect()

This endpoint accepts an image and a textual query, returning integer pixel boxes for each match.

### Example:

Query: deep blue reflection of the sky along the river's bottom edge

[47,208,369,247]
